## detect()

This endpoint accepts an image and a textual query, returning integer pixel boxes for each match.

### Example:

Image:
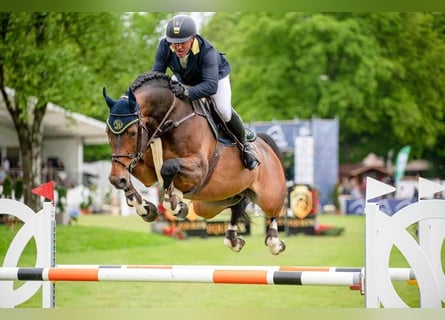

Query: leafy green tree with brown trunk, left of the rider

[0,12,166,210]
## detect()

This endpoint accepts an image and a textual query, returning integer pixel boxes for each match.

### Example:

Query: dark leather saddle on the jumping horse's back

[192,97,256,147]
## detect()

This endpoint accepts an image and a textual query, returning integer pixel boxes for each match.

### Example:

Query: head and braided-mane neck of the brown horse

[103,72,192,189]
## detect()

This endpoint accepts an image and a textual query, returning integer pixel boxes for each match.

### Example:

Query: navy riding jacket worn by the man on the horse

[152,35,231,100]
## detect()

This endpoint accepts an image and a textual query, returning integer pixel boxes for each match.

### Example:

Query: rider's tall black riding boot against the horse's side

[226,110,260,170]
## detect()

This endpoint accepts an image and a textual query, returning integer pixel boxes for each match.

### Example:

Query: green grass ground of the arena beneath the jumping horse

[0,215,438,308]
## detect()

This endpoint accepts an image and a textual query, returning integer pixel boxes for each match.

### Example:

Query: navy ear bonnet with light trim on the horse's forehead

[107,96,140,134]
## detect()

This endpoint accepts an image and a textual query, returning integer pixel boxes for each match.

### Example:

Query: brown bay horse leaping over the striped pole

[103,72,287,255]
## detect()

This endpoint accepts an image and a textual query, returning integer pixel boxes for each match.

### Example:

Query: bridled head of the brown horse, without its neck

[103,88,148,189]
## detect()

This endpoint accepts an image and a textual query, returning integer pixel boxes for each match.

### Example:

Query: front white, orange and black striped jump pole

[0,266,362,287]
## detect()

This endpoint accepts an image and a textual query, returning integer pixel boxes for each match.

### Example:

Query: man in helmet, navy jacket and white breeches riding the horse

[152,15,259,170]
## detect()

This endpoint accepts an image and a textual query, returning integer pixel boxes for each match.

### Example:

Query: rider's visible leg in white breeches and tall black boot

[213,76,259,170]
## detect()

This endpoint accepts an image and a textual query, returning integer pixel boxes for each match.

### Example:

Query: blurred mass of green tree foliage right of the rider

[203,12,445,172]
